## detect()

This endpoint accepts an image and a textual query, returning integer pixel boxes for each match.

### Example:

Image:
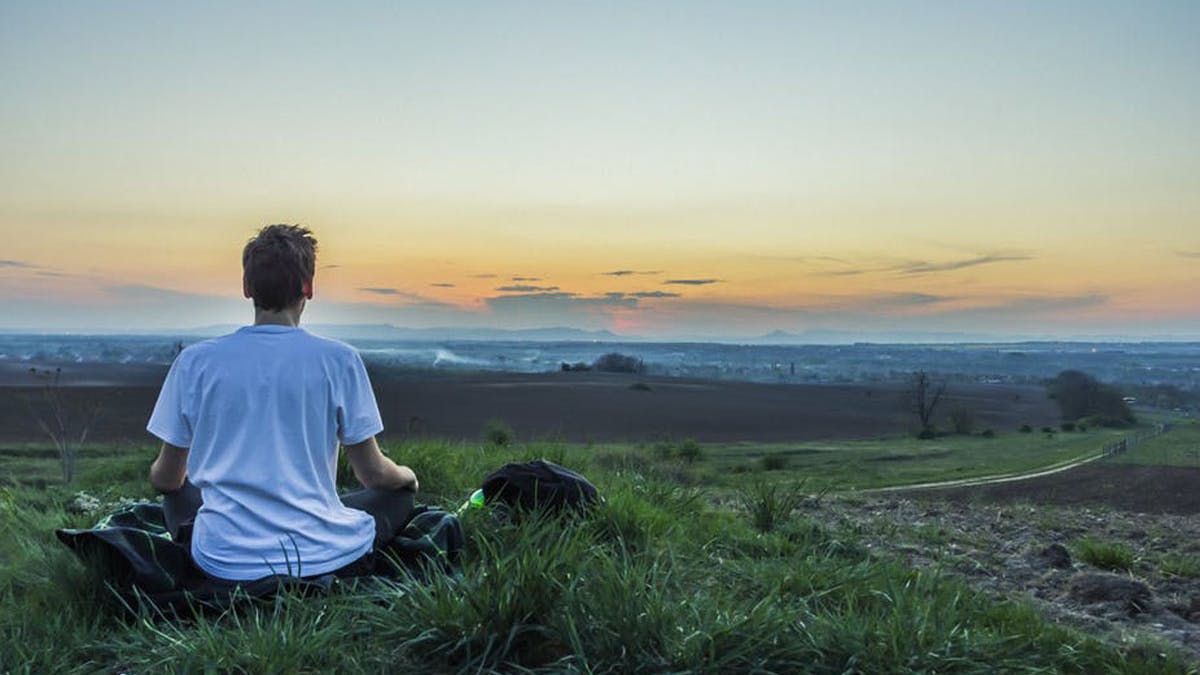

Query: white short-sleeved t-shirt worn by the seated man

[146,325,383,580]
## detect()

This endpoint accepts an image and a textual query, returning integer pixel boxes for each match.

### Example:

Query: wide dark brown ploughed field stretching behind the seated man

[0,365,1057,442]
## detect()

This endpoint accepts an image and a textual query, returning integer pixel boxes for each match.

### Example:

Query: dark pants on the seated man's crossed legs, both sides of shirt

[162,480,415,577]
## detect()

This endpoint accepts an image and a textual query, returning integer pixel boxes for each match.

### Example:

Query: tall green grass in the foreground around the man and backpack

[0,435,1189,673]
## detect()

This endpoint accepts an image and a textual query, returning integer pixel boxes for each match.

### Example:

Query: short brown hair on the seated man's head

[241,225,317,311]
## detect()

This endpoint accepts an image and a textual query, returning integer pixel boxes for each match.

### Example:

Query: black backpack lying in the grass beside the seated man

[482,459,600,512]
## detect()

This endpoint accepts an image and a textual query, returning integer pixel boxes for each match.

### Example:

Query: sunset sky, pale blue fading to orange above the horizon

[0,0,1200,340]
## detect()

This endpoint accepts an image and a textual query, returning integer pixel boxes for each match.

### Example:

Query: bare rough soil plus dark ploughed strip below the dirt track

[822,462,1200,662]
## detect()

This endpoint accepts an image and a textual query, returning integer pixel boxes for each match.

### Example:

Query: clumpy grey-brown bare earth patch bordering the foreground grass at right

[805,492,1200,661]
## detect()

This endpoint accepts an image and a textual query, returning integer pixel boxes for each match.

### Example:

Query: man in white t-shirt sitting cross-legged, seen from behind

[146,225,418,581]
